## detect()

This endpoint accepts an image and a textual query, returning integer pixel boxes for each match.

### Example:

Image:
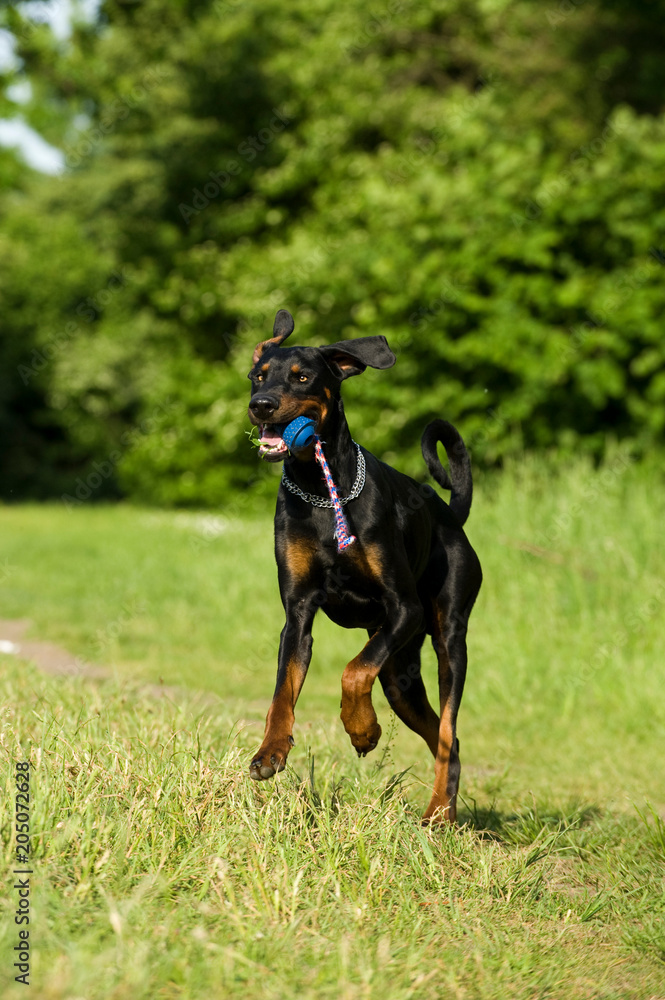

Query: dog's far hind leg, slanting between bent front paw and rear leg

[379,632,439,758]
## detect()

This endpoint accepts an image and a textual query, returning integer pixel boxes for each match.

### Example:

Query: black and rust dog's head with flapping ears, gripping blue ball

[247,309,395,462]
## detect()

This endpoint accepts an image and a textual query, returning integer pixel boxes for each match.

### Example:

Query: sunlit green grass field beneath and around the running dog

[0,453,665,1000]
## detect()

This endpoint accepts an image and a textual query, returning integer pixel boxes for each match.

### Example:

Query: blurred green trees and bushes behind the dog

[0,0,665,506]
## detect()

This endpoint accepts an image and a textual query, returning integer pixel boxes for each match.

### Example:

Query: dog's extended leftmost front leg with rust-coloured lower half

[249,600,317,781]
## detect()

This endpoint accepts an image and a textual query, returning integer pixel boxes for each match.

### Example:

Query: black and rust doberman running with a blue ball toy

[248,309,482,822]
